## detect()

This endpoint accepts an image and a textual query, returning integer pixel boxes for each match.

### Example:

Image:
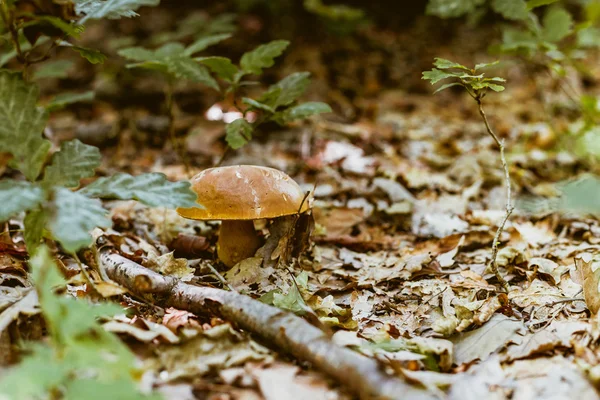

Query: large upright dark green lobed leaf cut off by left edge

[0,71,50,181]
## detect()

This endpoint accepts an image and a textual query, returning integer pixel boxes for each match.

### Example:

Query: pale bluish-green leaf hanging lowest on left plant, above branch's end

[49,187,112,253]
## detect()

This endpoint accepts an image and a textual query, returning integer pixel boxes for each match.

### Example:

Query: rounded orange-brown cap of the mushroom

[177,165,309,220]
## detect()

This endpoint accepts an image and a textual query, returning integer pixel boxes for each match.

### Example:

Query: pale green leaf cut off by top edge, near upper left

[75,0,160,24]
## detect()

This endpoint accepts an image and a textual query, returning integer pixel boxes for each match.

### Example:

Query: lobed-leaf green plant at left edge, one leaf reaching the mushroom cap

[0,71,196,253]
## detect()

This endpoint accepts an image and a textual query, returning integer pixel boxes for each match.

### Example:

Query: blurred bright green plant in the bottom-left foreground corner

[0,246,162,400]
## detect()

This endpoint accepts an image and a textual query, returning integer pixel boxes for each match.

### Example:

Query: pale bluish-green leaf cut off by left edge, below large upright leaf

[0,179,44,222]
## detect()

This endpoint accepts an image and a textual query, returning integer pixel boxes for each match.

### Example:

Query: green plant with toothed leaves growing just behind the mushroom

[119,38,331,158]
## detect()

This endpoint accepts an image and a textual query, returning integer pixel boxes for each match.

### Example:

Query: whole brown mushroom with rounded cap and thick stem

[177,165,309,267]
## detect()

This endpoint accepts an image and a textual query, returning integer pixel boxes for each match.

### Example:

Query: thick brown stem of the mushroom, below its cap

[217,220,261,268]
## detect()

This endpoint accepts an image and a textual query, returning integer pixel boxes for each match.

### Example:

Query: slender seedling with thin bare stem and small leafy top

[423,58,514,291]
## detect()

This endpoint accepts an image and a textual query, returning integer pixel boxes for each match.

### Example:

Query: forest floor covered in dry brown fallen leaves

[0,3,600,400]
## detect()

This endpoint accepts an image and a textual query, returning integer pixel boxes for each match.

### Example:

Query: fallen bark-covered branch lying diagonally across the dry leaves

[100,252,435,400]
